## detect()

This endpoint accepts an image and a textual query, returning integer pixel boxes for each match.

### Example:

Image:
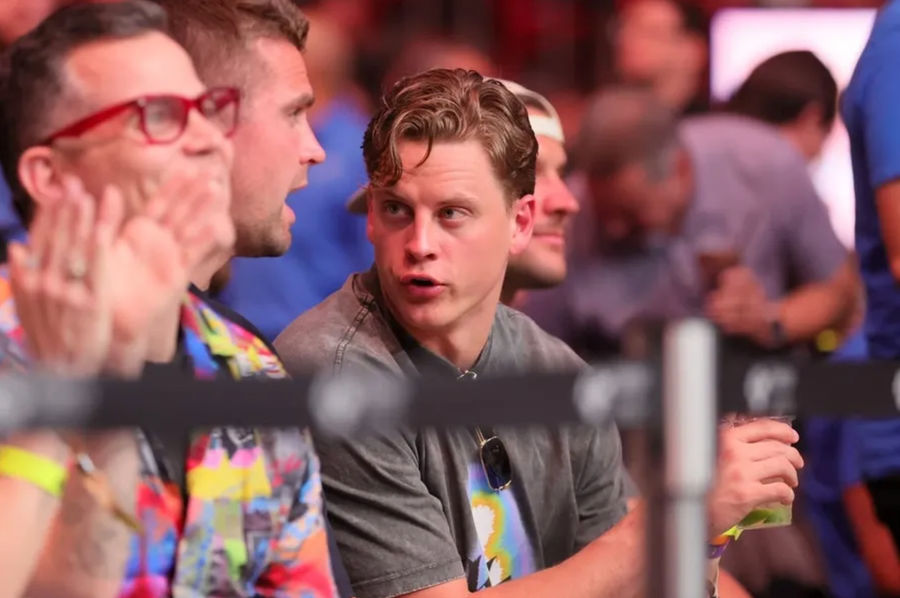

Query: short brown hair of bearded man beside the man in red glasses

[155,0,309,90]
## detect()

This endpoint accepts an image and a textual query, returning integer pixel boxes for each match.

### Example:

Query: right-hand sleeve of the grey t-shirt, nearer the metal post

[572,424,627,550]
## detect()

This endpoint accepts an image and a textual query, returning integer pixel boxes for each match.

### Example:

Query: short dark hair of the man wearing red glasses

[0,0,168,224]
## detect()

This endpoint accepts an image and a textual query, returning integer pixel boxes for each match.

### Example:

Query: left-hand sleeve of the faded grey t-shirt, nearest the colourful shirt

[316,432,464,598]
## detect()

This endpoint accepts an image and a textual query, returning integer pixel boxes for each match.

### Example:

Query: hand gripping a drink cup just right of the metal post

[709,419,803,538]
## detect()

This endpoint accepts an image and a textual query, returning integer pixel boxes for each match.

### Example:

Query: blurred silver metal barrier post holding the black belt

[647,319,716,598]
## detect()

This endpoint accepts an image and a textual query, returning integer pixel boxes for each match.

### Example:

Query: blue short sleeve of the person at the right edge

[859,58,900,188]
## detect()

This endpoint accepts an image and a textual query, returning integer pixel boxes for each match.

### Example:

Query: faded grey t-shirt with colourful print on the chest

[275,272,625,598]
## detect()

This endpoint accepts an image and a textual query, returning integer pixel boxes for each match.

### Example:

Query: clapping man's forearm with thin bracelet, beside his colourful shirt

[25,430,140,598]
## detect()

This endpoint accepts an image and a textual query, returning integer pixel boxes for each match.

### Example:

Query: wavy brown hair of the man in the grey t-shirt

[363,69,538,202]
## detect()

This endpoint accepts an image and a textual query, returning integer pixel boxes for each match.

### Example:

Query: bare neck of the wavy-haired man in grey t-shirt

[388,288,500,372]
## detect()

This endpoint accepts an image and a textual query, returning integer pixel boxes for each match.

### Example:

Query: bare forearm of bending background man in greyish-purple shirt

[778,261,861,343]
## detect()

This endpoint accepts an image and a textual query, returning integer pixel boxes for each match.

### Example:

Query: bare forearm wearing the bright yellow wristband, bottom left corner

[0,432,69,596]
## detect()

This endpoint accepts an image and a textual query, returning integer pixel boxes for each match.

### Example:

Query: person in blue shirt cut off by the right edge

[838,0,900,596]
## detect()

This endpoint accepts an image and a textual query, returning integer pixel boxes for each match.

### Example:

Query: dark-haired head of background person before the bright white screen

[725,50,837,160]
